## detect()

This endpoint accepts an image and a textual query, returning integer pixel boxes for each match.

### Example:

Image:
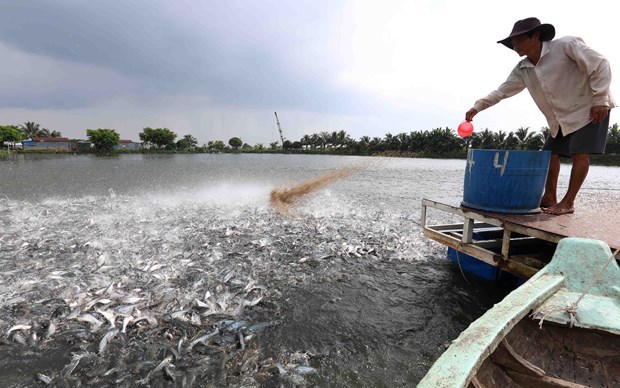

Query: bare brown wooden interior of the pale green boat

[469,318,620,388]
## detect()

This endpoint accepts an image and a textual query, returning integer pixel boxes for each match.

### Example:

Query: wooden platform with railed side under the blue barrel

[421,199,620,278]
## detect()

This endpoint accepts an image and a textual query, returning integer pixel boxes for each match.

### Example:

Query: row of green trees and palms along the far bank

[0,122,620,155]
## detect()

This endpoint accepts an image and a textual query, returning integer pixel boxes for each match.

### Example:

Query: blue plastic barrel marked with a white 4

[461,149,551,214]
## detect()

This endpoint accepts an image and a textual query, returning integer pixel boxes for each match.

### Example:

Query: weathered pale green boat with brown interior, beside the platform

[418,238,620,388]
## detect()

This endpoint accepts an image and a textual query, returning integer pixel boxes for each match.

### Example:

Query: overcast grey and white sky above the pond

[0,0,620,145]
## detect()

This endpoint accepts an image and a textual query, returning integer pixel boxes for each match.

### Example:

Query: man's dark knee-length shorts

[543,115,609,156]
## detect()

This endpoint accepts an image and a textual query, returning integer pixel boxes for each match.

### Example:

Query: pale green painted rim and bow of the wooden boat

[418,237,620,388]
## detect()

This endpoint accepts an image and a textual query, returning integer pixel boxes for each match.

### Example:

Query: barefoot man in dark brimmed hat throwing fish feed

[465,18,616,215]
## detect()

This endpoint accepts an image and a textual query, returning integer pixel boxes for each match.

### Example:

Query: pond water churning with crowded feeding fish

[0,155,618,387]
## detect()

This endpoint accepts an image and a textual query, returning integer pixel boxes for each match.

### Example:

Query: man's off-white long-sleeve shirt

[474,36,616,137]
